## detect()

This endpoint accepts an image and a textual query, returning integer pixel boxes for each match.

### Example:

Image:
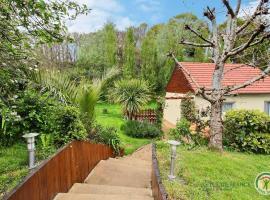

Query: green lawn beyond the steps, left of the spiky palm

[96,103,151,154]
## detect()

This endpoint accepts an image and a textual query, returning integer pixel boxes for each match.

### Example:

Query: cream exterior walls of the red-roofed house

[164,93,270,124]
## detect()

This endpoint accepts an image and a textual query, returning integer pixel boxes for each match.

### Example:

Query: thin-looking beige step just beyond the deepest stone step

[106,157,151,170]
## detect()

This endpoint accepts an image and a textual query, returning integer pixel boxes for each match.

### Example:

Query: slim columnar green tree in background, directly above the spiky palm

[123,27,136,78]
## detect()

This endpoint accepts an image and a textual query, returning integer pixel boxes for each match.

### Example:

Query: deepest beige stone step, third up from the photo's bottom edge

[85,161,151,188]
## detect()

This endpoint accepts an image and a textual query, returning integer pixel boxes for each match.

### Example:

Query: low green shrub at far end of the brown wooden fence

[89,124,120,154]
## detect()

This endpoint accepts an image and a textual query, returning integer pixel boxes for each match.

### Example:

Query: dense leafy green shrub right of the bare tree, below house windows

[224,110,270,153]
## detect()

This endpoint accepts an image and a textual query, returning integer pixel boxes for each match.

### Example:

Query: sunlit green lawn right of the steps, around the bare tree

[157,142,270,200]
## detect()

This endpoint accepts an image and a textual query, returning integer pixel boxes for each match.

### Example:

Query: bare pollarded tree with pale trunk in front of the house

[170,0,270,150]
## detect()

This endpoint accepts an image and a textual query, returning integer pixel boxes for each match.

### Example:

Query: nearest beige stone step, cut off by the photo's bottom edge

[54,193,154,200]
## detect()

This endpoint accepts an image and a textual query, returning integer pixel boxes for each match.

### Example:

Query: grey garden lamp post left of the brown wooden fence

[23,133,38,169]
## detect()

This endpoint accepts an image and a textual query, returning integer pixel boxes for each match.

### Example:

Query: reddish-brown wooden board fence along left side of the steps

[4,141,114,200]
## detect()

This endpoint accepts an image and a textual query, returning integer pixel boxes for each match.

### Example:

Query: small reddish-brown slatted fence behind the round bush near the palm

[125,109,157,124]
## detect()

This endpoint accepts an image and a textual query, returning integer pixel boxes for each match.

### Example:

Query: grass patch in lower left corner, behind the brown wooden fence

[0,144,28,199]
